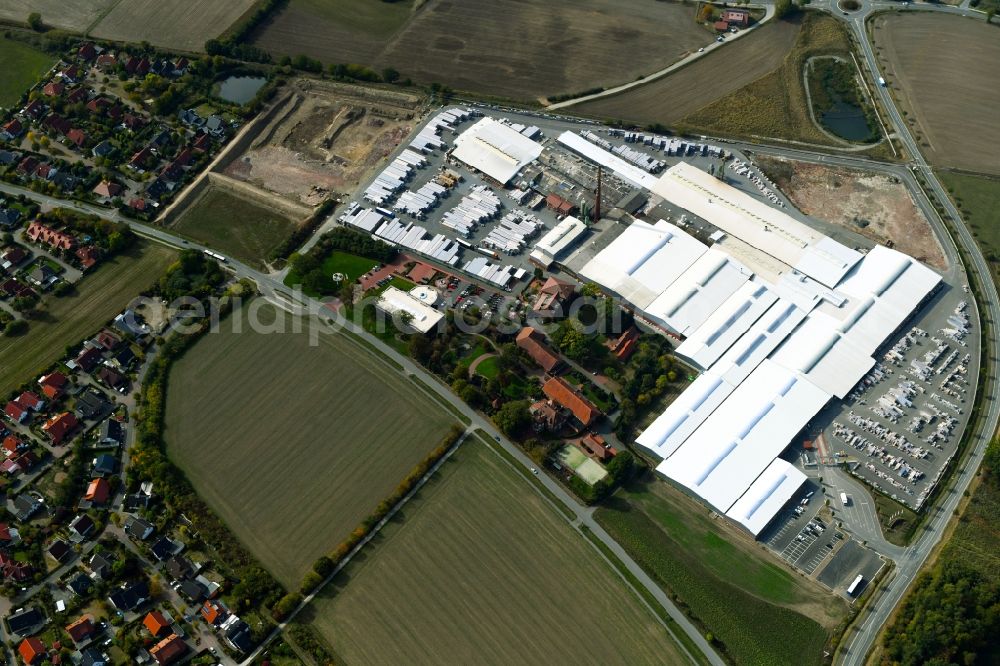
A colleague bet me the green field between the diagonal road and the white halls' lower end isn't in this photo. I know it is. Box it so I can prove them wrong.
[595,476,847,664]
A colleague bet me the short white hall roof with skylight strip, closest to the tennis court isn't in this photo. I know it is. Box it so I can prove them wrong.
[635,372,734,458]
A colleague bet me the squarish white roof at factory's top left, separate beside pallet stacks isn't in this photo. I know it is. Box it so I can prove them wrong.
[452,117,542,184]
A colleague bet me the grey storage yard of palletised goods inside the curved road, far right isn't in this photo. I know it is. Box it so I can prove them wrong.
[824,286,979,512]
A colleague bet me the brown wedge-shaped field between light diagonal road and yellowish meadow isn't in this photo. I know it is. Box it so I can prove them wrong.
[571,21,799,125]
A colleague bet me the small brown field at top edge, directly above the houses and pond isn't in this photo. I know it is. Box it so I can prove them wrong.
[91,0,254,51]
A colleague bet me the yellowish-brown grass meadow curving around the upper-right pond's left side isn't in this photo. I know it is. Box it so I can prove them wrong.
[677,11,880,145]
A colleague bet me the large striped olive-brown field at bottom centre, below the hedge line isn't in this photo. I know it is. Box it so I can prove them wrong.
[310,438,687,664]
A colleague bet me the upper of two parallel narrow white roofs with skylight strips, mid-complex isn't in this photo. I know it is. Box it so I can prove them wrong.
[677,281,778,370]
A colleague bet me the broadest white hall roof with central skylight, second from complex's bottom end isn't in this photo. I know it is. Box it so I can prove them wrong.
[657,360,830,512]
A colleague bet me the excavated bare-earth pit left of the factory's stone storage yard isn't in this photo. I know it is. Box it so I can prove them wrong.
[224,81,422,205]
